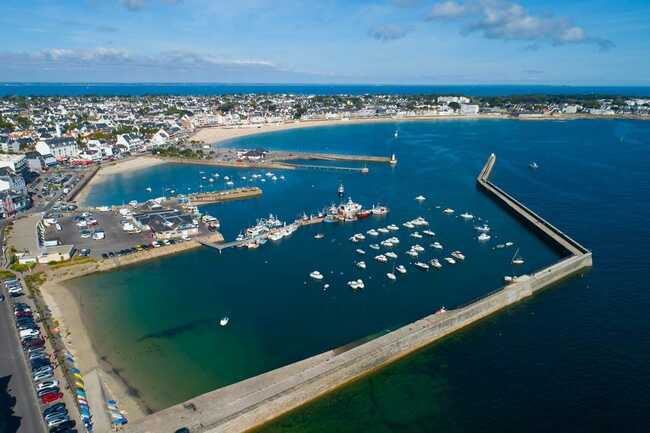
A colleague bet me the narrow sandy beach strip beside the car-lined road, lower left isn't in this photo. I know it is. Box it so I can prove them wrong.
[40,281,150,421]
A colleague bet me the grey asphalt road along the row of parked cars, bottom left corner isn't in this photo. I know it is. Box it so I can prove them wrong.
[0,288,47,433]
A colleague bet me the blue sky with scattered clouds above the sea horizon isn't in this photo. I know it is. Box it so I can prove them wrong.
[0,0,650,85]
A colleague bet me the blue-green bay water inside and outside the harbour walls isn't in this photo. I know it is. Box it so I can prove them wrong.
[68,116,650,432]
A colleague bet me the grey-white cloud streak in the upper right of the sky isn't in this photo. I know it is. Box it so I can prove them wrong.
[428,0,614,50]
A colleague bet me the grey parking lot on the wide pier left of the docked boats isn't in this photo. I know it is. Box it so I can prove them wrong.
[46,212,153,258]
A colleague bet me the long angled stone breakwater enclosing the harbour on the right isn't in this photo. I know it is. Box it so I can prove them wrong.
[125,155,592,433]
